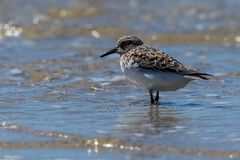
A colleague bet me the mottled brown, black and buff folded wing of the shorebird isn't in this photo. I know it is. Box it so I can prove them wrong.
[129,46,211,79]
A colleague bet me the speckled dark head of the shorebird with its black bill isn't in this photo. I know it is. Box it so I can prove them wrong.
[100,35,143,58]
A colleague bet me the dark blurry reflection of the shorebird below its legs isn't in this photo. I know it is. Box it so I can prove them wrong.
[116,102,183,135]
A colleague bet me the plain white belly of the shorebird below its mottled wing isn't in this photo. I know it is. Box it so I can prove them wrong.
[122,68,193,91]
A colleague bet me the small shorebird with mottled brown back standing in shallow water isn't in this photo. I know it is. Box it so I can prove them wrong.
[100,35,212,104]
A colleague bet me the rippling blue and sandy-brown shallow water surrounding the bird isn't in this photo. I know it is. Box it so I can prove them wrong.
[0,0,240,160]
